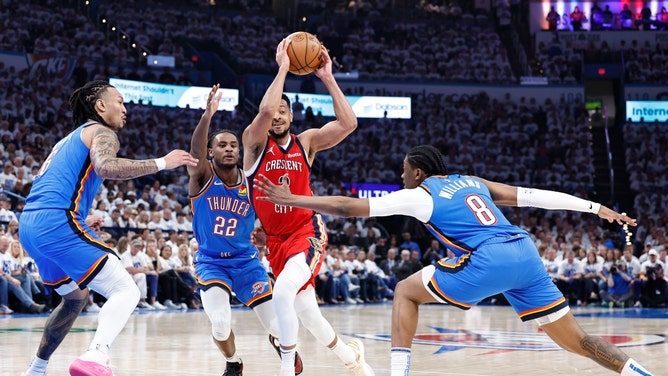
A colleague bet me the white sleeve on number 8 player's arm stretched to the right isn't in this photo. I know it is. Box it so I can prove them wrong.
[517,187,601,214]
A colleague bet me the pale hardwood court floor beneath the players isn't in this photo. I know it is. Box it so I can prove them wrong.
[0,303,668,376]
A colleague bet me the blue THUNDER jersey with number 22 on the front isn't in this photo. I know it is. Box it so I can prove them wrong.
[190,163,257,259]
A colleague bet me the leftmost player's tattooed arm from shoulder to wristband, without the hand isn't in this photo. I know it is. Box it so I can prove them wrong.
[90,127,158,180]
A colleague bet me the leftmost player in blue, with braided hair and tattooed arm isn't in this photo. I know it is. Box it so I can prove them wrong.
[19,81,197,376]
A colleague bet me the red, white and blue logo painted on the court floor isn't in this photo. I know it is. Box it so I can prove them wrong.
[357,326,666,354]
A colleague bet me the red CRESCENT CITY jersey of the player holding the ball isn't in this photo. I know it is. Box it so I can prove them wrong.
[248,134,317,235]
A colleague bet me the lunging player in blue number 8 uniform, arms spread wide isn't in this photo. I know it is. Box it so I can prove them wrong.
[254,146,651,376]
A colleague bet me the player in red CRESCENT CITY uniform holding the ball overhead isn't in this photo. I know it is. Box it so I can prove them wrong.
[242,39,374,376]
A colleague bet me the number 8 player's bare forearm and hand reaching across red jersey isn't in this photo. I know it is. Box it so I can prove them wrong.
[253,174,369,217]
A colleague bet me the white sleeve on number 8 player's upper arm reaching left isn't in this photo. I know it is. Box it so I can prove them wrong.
[369,188,434,223]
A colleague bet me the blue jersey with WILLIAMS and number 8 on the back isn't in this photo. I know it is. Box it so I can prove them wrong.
[420,175,528,256]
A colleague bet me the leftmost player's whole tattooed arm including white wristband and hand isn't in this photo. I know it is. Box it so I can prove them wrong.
[90,125,197,180]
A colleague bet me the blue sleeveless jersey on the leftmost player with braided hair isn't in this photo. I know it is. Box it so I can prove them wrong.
[23,122,103,218]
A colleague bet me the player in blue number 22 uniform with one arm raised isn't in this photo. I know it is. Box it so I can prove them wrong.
[188,85,303,376]
